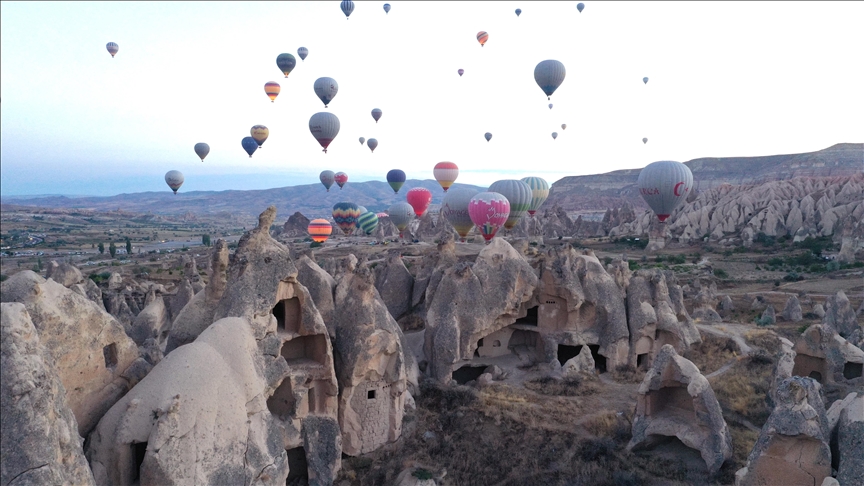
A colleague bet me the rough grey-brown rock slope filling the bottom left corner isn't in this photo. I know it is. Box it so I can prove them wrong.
[0,303,93,486]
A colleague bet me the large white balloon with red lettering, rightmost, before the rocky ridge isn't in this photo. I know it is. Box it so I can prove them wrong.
[636,160,693,221]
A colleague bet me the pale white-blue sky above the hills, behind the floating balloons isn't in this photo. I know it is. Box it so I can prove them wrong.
[0,0,864,195]
